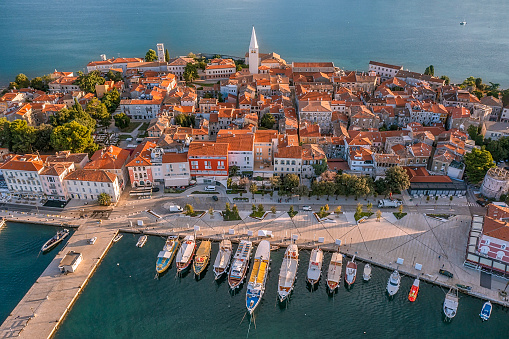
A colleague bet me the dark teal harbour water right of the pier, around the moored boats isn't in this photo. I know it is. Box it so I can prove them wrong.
[56,234,509,338]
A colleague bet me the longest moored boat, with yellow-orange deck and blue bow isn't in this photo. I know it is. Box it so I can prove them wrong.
[246,240,270,314]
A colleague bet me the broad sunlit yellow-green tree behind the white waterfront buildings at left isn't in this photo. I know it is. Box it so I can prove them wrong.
[50,121,98,153]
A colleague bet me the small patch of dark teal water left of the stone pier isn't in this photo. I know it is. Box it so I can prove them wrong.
[0,223,72,323]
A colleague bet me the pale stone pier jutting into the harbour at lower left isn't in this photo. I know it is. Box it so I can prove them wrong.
[0,218,117,338]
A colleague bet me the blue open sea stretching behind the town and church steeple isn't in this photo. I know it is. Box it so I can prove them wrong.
[0,0,509,88]
